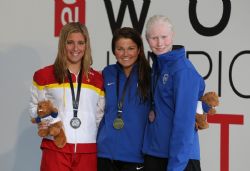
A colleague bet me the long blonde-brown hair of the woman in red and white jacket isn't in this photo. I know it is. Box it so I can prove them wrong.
[54,22,93,84]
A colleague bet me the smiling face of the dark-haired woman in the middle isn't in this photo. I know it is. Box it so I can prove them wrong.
[114,38,140,76]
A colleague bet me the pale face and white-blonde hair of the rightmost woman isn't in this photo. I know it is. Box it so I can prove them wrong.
[147,22,174,55]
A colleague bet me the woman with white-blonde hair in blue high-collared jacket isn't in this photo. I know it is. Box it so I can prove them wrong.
[143,15,205,171]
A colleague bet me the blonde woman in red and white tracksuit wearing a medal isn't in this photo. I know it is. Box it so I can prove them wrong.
[30,22,104,171]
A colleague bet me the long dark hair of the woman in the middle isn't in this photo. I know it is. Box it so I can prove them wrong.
[112,27,150,102]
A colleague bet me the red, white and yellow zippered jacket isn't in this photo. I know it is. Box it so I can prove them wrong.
[30,65,104,153]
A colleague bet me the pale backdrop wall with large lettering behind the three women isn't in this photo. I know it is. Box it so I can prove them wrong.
[0,0,250,171]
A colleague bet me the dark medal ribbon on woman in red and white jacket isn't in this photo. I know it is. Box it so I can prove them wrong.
[67,68,82,117]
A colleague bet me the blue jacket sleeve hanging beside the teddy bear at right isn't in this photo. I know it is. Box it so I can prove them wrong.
[167,69,203,171]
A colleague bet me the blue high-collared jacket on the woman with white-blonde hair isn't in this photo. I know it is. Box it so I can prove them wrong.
[143,46,205,171]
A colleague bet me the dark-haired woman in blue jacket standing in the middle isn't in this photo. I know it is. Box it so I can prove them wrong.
[97,27,150,171]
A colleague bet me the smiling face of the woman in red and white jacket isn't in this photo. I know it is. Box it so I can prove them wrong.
[66,33,86,67]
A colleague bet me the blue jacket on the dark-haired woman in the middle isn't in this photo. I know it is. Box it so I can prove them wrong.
[97,64,150,163]
